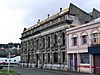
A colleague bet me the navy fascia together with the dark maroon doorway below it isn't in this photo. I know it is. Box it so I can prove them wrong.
[88,46,100,74]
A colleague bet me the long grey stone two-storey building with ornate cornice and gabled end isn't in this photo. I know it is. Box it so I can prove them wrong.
[20,4,100,70]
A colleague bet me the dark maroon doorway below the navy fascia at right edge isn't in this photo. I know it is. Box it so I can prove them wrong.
[93,55,100,74]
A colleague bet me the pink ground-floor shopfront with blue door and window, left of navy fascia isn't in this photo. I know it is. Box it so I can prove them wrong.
[67,53,93,73]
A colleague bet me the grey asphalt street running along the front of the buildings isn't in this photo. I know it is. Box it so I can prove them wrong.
[3,66,95,75]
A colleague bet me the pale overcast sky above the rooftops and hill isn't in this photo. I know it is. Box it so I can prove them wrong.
[0,0,100,44]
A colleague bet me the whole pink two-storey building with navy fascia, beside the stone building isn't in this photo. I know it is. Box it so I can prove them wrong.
[66,18,100,73]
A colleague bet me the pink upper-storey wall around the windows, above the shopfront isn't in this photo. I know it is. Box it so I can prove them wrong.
[66,23,100,53]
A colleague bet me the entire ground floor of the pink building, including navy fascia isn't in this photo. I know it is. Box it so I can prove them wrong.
[67,47,100,74]
